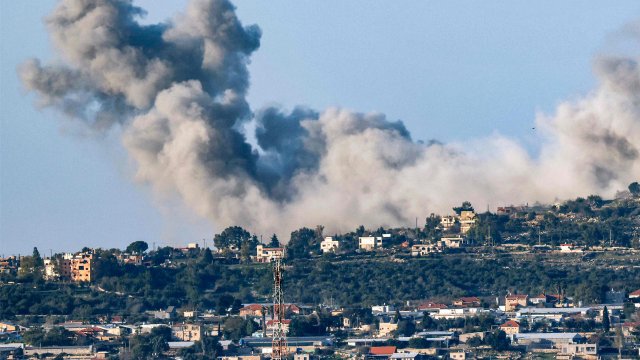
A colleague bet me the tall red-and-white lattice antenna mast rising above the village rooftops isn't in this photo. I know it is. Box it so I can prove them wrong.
[271,256,287,360]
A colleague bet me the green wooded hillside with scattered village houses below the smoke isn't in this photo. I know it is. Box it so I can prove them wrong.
[0,187,640,360]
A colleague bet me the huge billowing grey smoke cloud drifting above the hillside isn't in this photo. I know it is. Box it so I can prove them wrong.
[20,0,640,239]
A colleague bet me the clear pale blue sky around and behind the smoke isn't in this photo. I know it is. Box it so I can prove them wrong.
[0,0,640,256]
